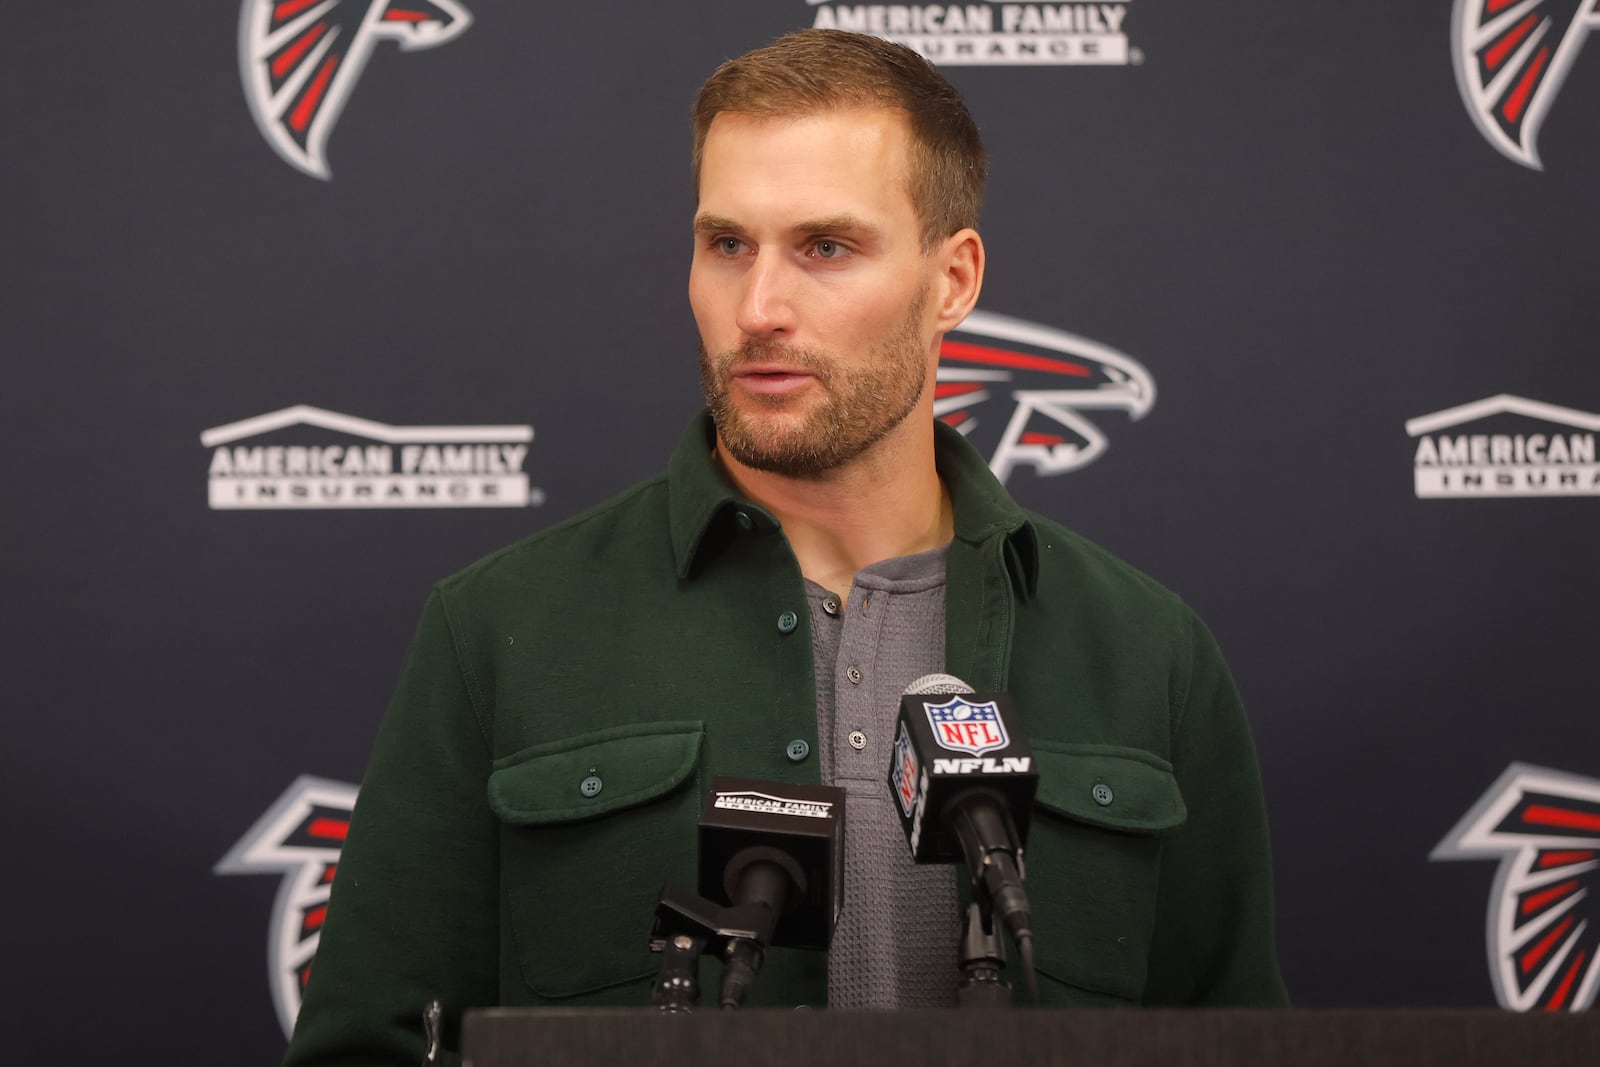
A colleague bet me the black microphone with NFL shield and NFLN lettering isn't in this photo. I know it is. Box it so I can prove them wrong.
[888,675,1038,977]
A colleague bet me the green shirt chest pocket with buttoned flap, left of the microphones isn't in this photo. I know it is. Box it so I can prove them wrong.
[488,721,704,1003]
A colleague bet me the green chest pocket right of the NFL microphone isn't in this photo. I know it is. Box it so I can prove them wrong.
[1027,741,1187,1005]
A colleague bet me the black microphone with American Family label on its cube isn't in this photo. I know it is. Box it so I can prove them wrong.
[699,777,845,1008]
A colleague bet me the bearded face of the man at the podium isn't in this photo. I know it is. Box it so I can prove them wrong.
[690,109,936,475]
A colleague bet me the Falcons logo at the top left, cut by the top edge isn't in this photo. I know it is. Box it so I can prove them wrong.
[238,0,472,181]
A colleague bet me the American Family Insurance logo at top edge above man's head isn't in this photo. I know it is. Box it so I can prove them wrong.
[806,0,1144,67]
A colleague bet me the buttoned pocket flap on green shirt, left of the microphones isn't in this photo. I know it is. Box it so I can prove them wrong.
[488,721,706,825]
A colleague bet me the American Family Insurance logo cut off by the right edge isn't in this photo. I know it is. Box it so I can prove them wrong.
[1405,394,1600,499]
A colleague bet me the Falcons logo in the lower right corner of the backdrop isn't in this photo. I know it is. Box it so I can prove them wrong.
[1429,763,1600,1011]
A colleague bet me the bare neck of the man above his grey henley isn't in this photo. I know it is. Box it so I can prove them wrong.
[717,416,955,598]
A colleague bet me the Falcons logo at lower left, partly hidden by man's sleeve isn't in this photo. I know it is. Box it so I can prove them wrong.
[214,774,355,1037]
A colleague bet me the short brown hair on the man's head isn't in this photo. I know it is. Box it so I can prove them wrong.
[694,29,989,250]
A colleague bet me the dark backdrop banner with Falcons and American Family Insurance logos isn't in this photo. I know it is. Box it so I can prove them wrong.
[0,0,1600,1065]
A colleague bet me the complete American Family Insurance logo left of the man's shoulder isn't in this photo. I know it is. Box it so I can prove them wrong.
[200,405,544,510]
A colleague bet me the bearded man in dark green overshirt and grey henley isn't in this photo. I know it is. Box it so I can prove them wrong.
[288,30,1285,1064]
